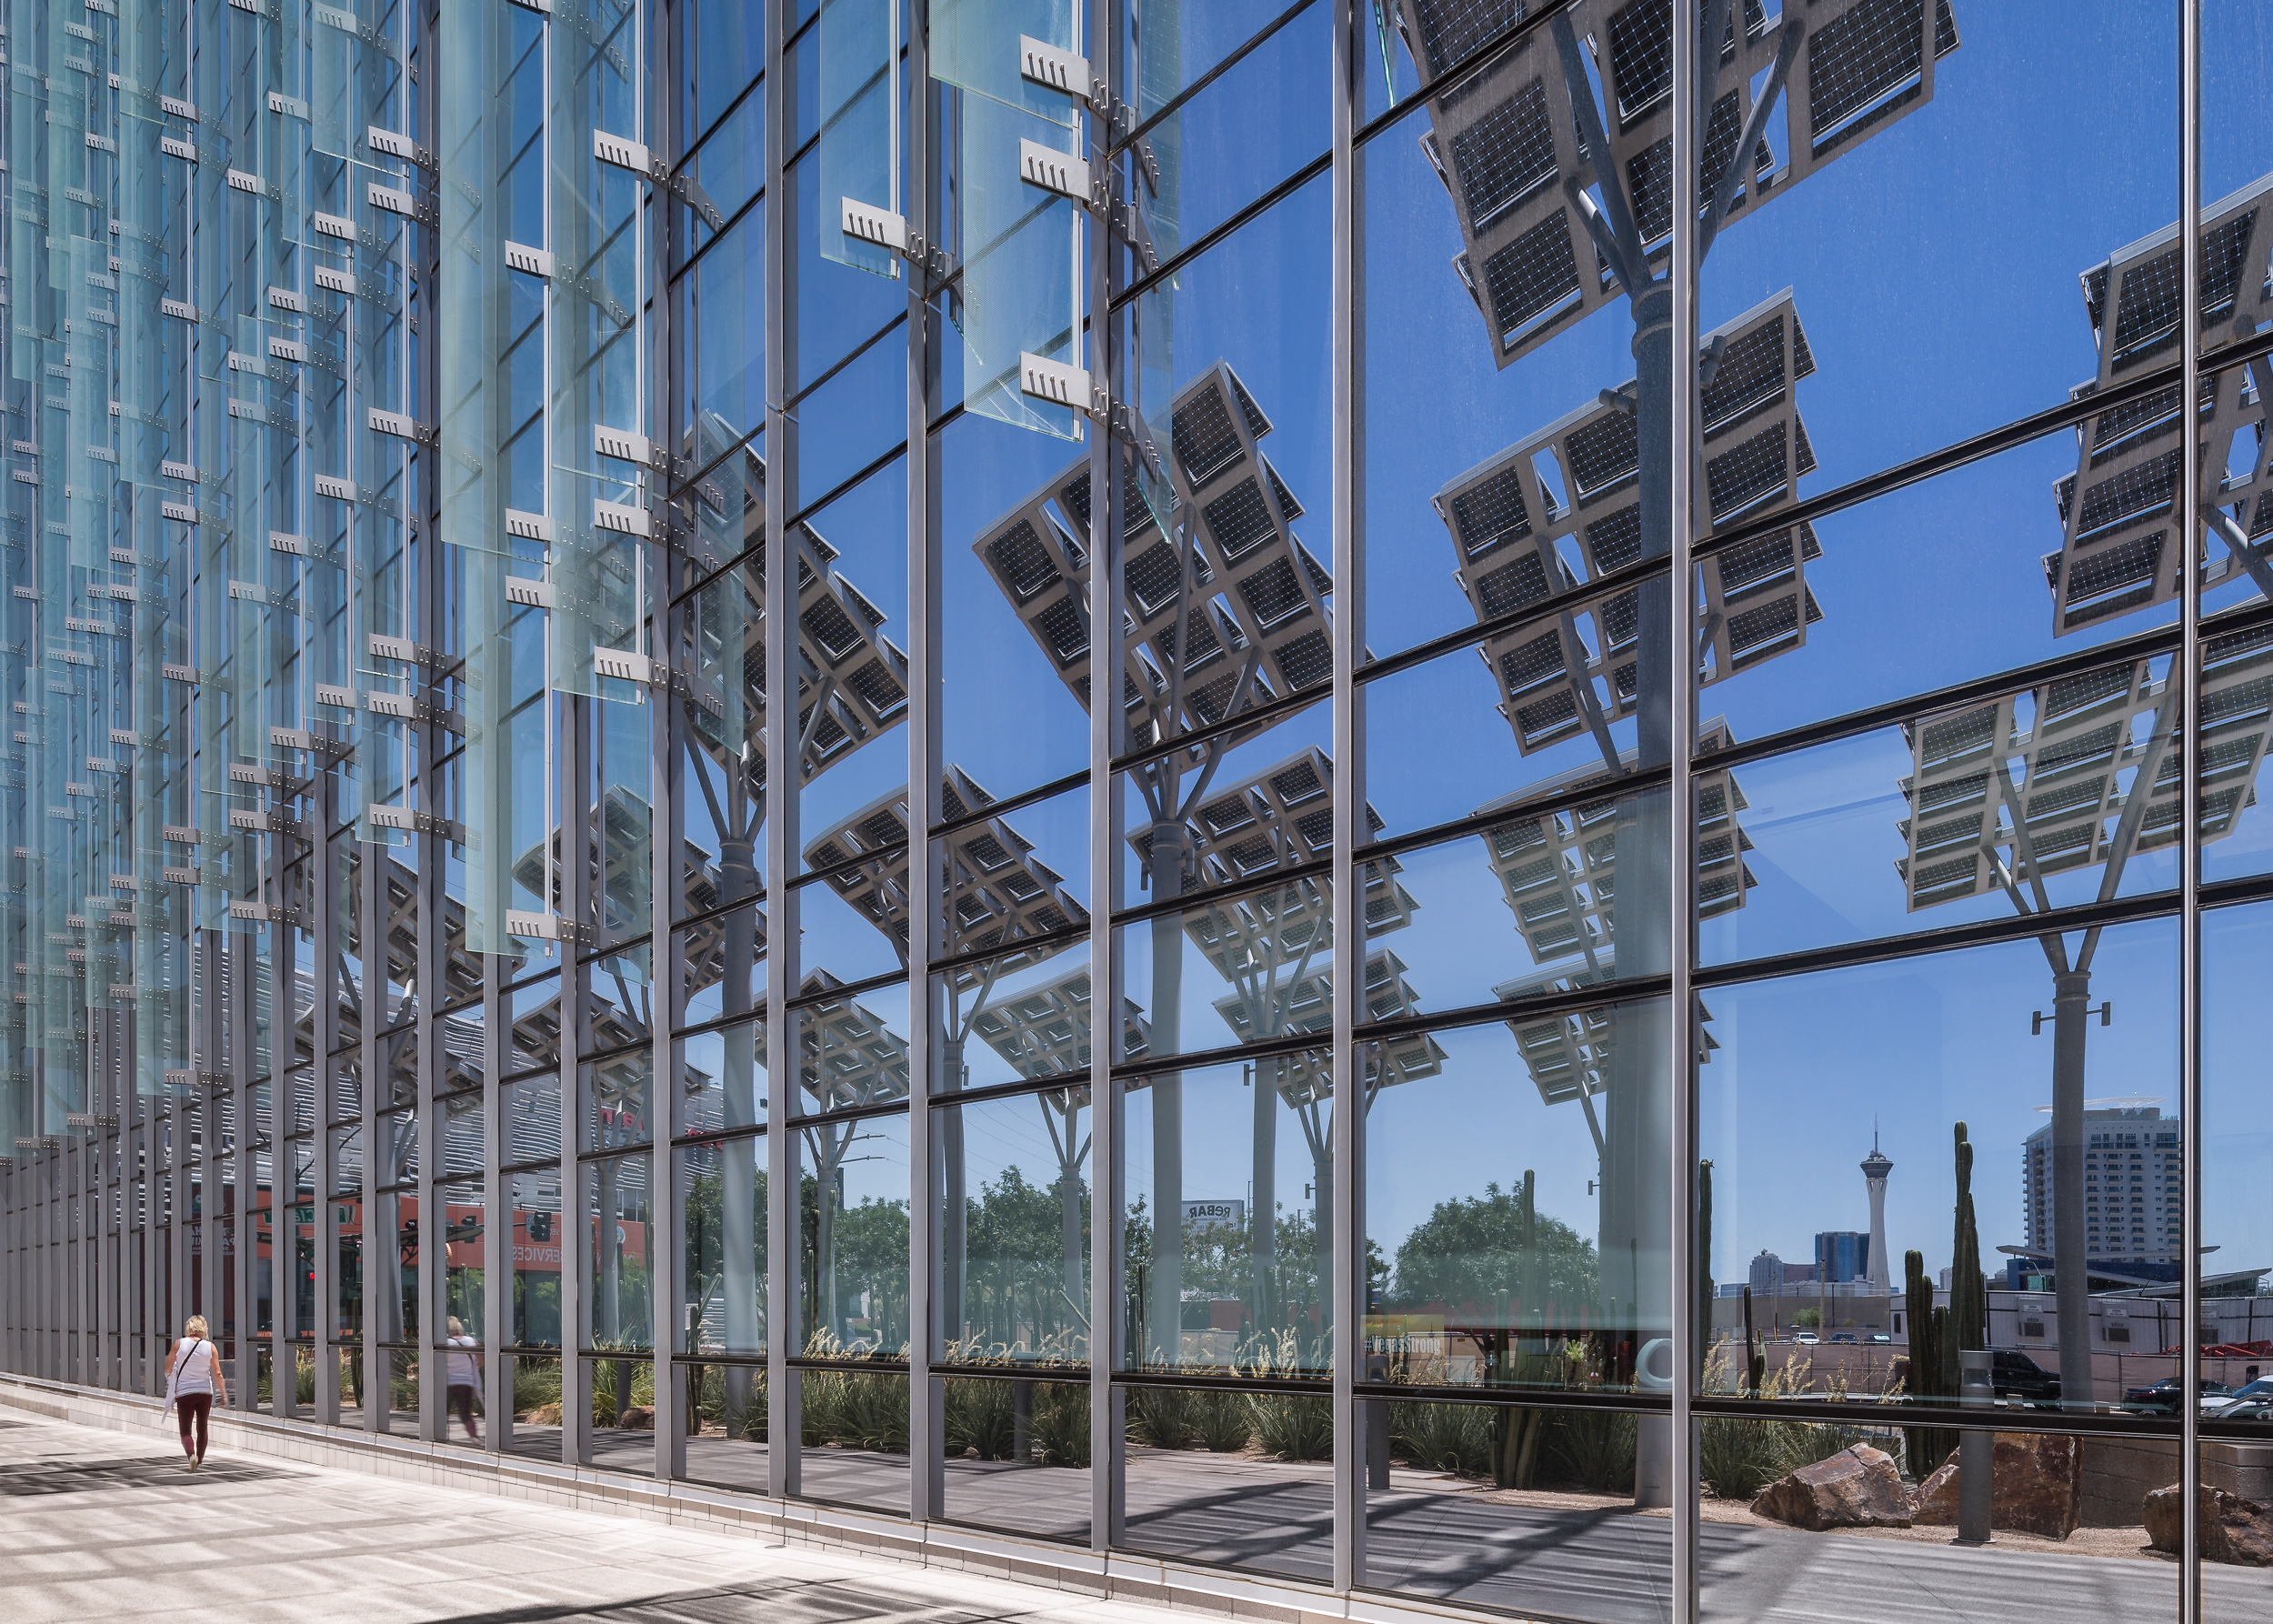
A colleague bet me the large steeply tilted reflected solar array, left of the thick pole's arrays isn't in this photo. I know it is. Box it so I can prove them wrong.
[976,362,1335,748]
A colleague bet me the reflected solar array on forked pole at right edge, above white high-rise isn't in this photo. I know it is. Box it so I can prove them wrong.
[1896,630,2273,910]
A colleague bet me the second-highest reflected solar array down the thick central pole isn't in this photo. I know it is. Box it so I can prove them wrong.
[1435,289,1823,755]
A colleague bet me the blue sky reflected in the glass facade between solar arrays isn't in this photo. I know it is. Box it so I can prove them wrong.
[768,0,2273,1278]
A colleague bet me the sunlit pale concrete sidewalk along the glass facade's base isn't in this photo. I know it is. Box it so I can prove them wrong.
[0,1412,1191,1624]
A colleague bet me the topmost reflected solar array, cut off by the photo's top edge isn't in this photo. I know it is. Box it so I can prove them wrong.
[1396,0,1958,366]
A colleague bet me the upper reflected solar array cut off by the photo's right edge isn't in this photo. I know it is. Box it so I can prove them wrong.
[2044,175,2273,637]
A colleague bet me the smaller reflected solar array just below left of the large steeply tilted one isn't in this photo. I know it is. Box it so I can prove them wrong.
[805,764,1089,989]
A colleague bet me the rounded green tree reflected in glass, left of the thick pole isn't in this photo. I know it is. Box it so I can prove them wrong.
[1389,1183,1600,1321]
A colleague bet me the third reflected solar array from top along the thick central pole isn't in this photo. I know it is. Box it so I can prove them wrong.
[1477,717,1757,978]
